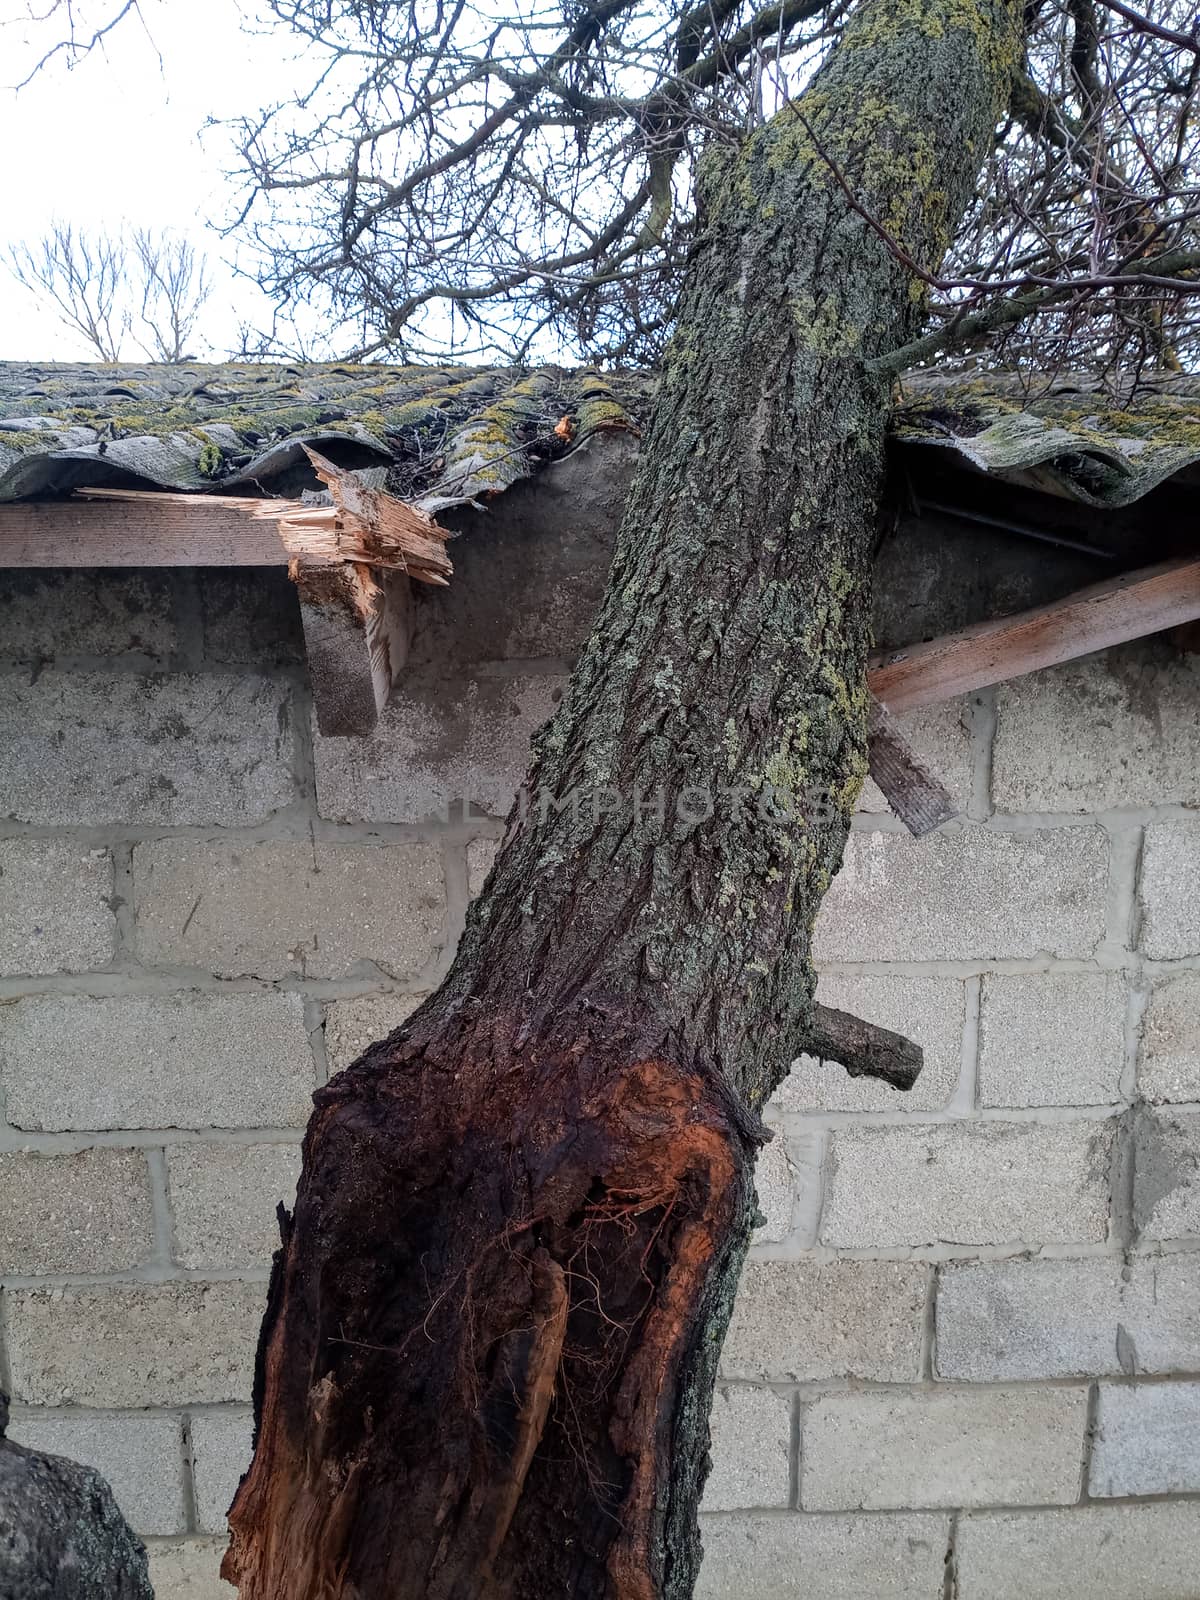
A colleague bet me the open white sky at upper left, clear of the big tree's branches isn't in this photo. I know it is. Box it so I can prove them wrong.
[0,0,298,360]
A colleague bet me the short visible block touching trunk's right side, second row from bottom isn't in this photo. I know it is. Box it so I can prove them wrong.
[704,1387,792,1510]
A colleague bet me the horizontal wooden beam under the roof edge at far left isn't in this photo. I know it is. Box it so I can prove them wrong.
[0,490,291,566]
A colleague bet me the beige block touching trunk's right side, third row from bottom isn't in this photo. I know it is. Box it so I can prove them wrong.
[722,1261,928,1382]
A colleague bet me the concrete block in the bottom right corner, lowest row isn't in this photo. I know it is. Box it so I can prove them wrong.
[955,1501,1200,1600]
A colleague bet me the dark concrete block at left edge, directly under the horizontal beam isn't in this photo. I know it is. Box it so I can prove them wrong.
[0,566,179,661]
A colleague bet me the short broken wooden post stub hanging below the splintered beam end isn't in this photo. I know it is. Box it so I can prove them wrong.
[299,562,411,738]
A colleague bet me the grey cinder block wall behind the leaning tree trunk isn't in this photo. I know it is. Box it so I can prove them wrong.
[0,478,1200,1600]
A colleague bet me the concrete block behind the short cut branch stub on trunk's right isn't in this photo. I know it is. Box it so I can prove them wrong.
[771,973,966,1114]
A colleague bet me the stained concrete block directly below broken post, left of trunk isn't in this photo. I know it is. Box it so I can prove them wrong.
[314,669,566,822]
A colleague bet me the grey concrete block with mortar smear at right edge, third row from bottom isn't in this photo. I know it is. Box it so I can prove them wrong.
[936,1253,1200,1382]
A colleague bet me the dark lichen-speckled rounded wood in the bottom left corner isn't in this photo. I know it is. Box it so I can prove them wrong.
[0,1394,154,1600]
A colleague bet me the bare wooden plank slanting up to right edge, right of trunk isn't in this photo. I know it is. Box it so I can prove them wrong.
[867,558,1200,712]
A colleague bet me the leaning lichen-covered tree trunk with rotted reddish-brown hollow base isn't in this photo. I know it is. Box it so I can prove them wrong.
[226,0,1021,1600]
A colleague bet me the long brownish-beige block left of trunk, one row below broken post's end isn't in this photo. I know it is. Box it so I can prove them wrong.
[133,844,446,978]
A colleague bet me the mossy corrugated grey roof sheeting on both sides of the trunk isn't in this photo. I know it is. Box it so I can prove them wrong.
[0,362,1200,512]
